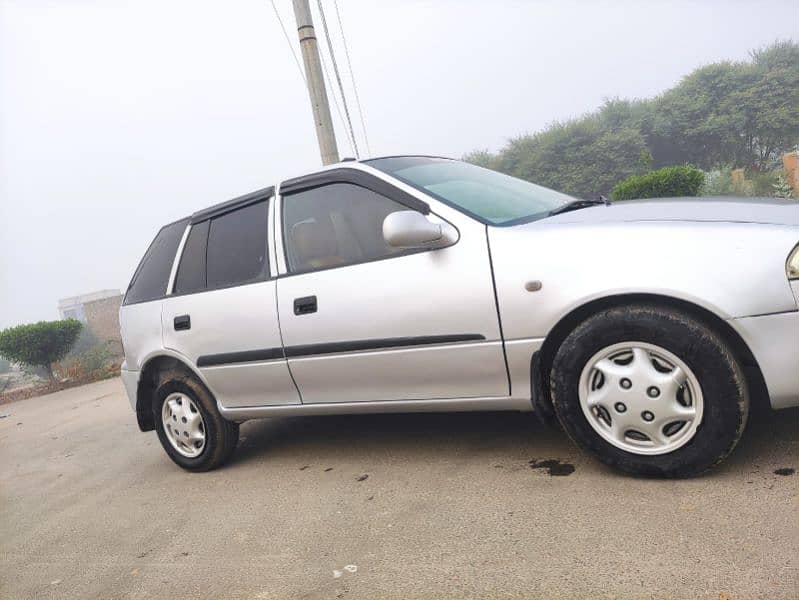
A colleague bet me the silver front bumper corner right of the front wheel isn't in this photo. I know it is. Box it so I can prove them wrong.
[730,312,799,408]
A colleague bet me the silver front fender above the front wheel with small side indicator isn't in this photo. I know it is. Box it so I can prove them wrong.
[489,219,799,340]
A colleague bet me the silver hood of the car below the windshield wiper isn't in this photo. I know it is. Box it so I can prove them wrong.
[536,198,799,226]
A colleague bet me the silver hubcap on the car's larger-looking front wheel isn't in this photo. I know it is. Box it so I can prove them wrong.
[579,342,703,455]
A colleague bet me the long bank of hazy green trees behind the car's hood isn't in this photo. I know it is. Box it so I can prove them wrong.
[464,40,799,191]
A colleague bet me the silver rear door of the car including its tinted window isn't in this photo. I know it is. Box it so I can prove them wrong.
[161,188,300,407]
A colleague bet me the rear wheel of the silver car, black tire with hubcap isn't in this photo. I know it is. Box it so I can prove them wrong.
[153,370,239,471]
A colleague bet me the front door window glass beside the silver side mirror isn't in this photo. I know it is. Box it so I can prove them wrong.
[283,183,408,272]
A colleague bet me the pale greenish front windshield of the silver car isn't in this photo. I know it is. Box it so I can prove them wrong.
[364,156,575,225]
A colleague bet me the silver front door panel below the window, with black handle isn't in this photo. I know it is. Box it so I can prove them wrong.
[275,180,509,403]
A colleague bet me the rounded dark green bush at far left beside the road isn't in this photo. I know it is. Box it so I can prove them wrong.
[0,319,83,380]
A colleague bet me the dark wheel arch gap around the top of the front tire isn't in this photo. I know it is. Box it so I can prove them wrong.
[531,293,771,423]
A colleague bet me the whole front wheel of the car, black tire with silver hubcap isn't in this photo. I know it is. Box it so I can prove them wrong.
[550,305,749,477]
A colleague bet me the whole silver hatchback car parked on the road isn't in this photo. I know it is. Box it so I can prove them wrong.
[120,156,799,477]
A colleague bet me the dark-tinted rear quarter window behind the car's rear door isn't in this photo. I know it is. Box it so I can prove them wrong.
[125,219,188,304]
